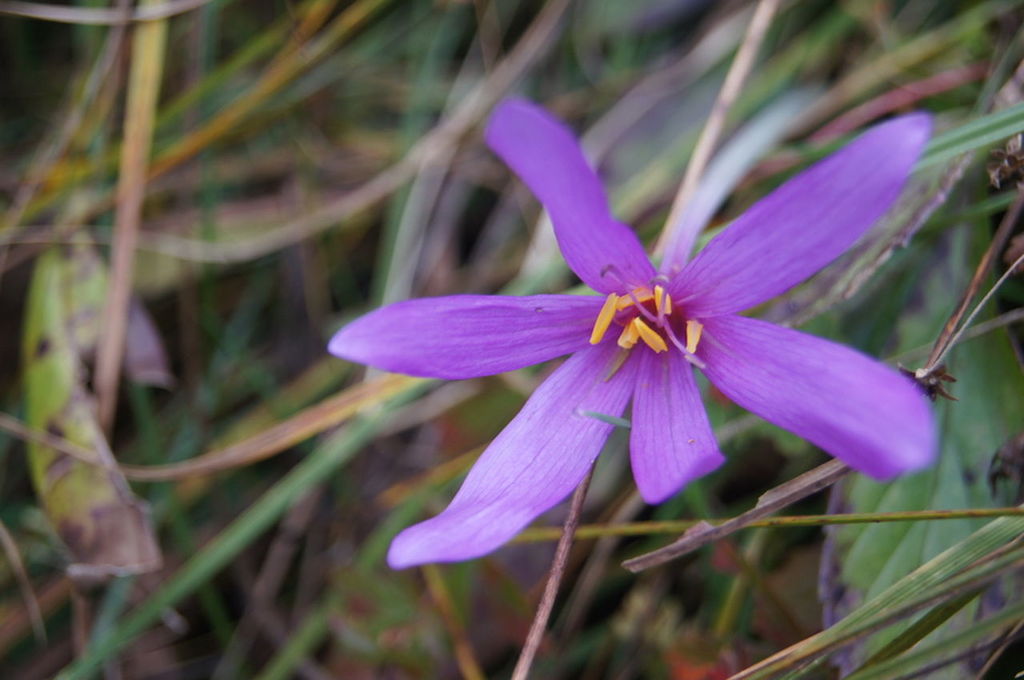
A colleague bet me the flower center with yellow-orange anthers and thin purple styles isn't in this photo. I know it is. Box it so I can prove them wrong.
[590,286,703,360]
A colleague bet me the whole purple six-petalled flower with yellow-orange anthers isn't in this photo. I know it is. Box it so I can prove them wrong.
[330,100,935,568]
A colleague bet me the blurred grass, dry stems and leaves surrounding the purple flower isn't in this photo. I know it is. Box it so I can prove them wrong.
[0,0,1024,680]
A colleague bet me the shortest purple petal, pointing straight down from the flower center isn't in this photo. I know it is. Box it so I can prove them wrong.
[630,351,725,503]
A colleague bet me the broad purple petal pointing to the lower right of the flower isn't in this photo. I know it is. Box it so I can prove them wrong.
[697,316,936,479]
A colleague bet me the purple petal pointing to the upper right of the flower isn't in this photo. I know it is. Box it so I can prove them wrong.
[670,114,931,317]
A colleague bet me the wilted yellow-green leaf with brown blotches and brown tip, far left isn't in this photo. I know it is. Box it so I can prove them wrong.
[23,250,161,579]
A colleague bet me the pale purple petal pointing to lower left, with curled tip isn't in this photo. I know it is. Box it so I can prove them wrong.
[388,342,636,568]
